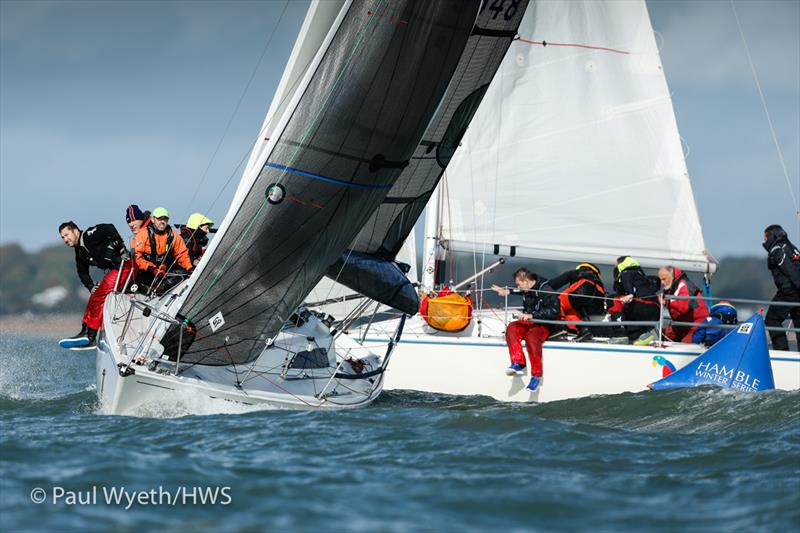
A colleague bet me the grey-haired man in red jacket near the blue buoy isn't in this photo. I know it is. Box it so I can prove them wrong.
[658,265,708,343]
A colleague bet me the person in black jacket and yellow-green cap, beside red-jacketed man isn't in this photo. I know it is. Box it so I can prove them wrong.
[609,256,661,344]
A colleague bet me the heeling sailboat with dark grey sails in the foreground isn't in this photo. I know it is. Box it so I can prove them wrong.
[97,0,527,414]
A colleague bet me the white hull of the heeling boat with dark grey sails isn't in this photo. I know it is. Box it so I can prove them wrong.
[97,294,396,416]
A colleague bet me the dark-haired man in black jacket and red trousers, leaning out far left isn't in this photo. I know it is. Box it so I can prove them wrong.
[58,220,133,348]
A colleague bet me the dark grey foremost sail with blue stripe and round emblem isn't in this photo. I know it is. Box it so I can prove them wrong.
[171,0,478,365]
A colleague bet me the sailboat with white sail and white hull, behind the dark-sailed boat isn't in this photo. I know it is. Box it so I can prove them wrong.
[351,0,800,402]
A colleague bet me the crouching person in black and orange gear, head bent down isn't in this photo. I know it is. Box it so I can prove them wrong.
[548,263,606,340]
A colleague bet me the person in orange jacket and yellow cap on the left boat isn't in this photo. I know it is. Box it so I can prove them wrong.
[133,207,192,284]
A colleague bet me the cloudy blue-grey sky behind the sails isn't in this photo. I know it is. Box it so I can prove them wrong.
[0,0,800,258]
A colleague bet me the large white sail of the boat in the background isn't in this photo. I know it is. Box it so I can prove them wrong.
[441,0,715,271]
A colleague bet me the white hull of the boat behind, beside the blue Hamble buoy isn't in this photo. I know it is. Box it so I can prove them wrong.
[352,315,800,402]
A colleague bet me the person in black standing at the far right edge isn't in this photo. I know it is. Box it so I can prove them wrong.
[763,224,800,350]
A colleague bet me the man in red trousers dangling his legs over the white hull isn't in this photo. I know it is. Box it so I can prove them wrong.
[492,268,561,391]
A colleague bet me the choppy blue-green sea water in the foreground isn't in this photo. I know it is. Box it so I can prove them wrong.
[0,333,800,532]
